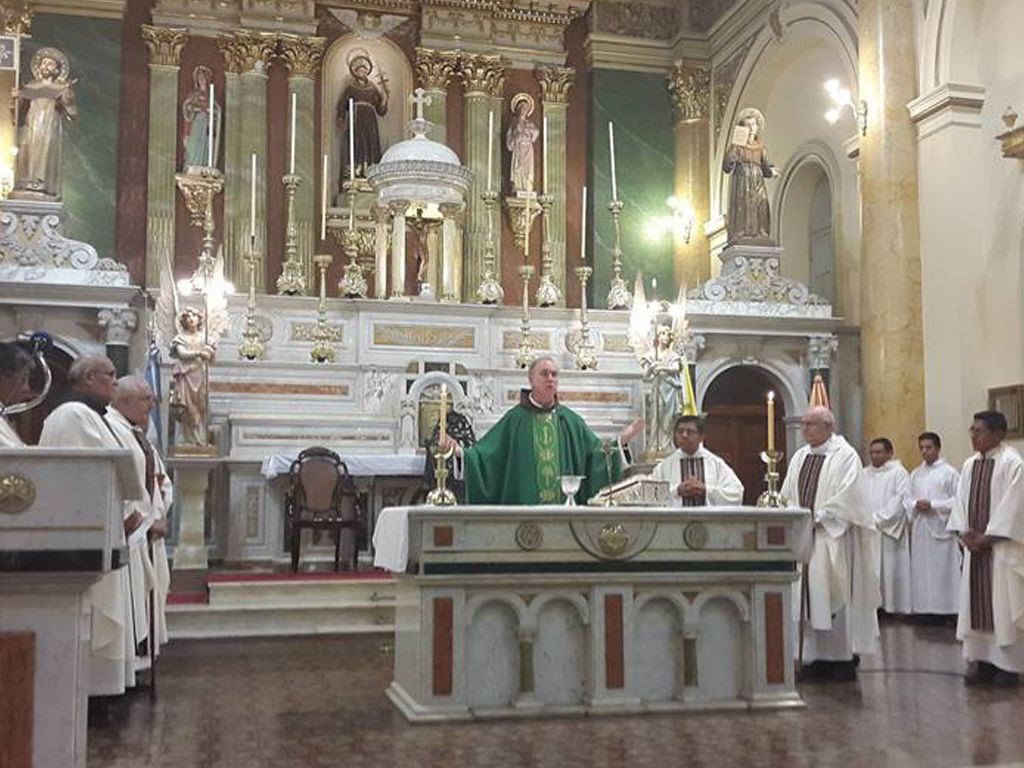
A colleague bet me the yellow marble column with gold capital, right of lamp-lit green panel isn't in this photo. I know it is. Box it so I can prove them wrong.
[669,61,711,287]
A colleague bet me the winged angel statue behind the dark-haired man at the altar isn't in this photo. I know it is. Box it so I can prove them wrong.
[629,274,696,460]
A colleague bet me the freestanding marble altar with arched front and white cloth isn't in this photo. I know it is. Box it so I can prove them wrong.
[375,506,810,722]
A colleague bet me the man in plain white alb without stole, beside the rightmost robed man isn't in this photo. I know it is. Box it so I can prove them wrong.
[904,432,961,615]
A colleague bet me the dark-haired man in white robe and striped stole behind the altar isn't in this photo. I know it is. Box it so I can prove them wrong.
[651,415,743,507]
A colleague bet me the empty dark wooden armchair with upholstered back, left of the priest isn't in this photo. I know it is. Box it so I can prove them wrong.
[285,447,365,572]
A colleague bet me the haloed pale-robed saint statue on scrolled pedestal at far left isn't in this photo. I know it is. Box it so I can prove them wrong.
[11,48,78,200]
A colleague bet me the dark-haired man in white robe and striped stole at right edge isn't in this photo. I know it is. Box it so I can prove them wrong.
[948,411,1024,686]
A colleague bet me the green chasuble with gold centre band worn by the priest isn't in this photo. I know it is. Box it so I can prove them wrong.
[463,391,622,505]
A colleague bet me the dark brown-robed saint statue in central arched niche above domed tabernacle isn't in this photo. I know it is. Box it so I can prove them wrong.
[337,48,389,183]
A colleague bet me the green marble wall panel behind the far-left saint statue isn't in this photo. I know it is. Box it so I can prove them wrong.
[22,13,122,257]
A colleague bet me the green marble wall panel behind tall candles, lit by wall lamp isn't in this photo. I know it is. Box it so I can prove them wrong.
[587,70,676,307]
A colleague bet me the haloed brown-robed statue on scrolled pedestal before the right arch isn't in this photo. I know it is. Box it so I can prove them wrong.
[722,106,778,246]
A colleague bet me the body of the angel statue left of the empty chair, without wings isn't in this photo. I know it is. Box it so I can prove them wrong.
[170,307,217,447]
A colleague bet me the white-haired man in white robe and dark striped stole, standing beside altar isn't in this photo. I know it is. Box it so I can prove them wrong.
[782,406,880,681]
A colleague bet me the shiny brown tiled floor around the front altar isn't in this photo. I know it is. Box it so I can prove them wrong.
[88,624,1024,768]
